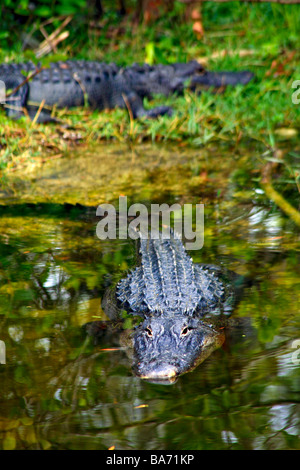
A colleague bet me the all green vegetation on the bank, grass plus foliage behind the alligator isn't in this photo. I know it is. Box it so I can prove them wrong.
[0,0,300,225]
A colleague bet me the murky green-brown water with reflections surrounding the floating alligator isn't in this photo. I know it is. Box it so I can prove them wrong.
[0,142,300,450]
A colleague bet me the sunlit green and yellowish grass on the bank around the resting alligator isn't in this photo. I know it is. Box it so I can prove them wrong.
[0,2,300,171]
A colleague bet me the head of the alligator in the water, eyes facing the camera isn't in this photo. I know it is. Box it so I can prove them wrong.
[133,314,224,383]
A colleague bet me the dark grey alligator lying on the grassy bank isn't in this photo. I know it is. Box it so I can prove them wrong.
[0,60,253,122]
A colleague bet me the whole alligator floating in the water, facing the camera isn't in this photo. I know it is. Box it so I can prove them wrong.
[87,232,240,383]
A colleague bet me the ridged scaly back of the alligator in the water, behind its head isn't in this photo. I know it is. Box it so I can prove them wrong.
[117,233,224,316]
